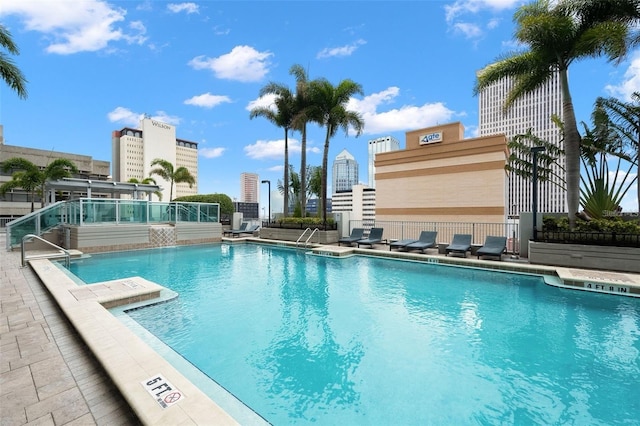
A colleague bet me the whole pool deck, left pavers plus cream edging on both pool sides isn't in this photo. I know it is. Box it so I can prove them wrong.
[0,233,640,426]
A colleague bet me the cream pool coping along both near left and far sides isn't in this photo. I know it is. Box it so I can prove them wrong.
[23,238,640,425]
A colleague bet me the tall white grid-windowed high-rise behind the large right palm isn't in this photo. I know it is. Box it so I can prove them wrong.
[478,73,567,216]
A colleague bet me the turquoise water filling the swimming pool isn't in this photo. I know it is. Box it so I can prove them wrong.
[71,244,640,425]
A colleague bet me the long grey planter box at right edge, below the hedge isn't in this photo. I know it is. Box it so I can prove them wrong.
[529,241,640,273]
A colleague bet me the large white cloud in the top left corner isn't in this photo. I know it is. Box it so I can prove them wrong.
[0,0,146,55]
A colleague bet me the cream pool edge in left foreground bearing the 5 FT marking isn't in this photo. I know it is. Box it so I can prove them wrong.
[29,259,238,425]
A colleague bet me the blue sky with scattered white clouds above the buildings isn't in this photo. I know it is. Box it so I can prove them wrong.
[0,0,640,210]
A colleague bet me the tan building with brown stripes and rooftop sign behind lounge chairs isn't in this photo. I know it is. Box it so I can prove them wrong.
[375,123,508,223]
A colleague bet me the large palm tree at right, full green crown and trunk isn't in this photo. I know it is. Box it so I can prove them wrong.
[474,0,640,228]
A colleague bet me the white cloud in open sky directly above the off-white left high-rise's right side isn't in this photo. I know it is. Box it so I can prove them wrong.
[189,46,273,82]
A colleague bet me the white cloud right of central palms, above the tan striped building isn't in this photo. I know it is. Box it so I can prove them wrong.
[347,87,456,135]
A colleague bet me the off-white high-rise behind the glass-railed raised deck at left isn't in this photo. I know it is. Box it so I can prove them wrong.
[111,117,198,201]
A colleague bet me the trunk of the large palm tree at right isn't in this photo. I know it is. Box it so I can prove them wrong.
[560,69,581,229]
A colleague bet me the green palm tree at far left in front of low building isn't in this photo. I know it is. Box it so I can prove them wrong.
[0,157,78,212]
